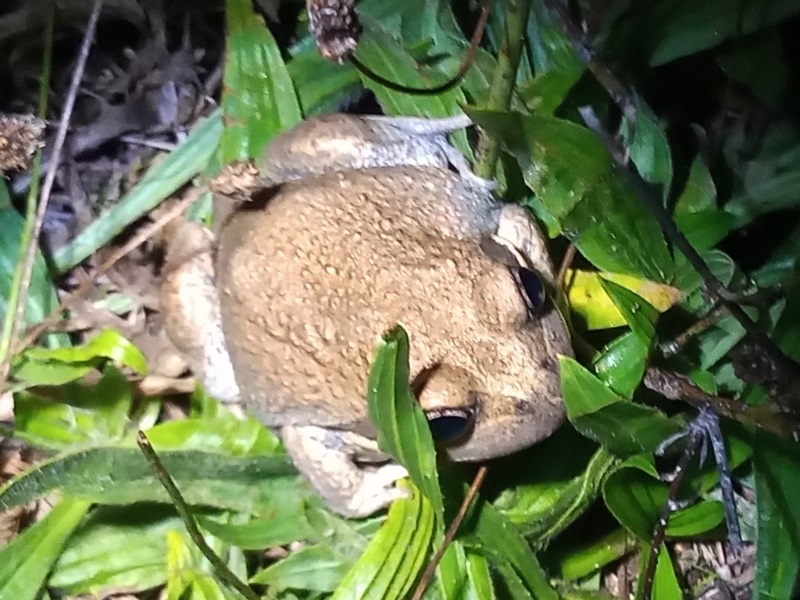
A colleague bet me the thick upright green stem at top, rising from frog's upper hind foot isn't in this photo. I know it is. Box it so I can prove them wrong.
[475,0,531,179]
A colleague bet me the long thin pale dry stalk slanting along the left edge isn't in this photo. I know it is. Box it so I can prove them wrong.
[0,0,103,380]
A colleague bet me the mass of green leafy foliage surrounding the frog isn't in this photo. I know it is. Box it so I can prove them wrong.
[0,0,800,599]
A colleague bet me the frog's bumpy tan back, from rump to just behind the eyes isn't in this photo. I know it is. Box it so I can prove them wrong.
[217,167,499,426]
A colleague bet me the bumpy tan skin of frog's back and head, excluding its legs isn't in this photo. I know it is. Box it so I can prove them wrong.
[216,167,570,461]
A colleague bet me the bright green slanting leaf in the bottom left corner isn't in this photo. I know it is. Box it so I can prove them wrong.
[0,498,90,600]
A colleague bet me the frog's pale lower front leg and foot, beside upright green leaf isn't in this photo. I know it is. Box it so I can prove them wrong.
[281,426,408,518]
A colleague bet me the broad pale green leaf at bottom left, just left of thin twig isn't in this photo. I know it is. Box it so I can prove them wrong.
[49,504,184,595]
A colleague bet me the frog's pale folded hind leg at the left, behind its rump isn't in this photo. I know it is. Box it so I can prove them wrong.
[161,222,239,404]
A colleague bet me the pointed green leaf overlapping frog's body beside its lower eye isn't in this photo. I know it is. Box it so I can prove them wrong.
[367,326,444,522]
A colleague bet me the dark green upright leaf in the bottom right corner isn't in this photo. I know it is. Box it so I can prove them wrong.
[753,434,800,600]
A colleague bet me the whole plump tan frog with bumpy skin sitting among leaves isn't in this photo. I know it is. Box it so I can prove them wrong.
[161,113,573,518]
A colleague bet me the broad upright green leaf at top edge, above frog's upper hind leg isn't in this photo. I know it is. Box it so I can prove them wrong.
[220,0,302,164]
